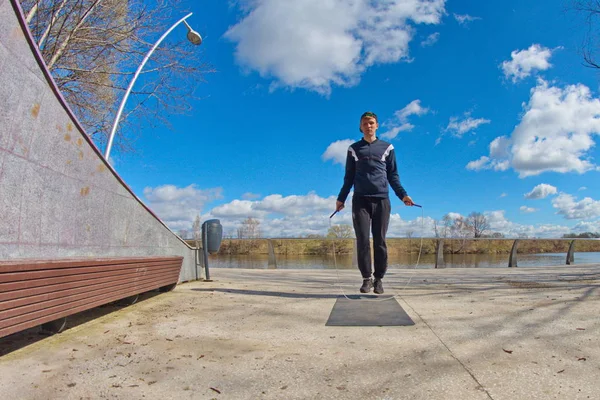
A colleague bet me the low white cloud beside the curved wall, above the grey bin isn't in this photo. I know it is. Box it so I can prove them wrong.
[144,185,223,232]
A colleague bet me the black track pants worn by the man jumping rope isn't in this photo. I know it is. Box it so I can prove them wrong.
[352,196,391,279]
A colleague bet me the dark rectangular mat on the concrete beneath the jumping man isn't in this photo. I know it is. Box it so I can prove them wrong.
[325,294,415,326]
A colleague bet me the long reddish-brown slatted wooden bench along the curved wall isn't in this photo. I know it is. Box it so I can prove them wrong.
[0,257,183,337]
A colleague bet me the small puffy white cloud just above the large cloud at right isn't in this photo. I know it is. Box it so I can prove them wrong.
[501,44,552,82]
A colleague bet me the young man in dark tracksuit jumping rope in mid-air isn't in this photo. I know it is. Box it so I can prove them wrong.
[335,112,415,294]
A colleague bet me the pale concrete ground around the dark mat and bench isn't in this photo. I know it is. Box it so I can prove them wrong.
[0,264,600,400]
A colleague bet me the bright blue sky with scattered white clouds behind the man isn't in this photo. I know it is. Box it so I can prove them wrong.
[112,0,600,237]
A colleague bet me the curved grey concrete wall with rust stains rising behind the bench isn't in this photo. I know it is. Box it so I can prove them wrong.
[0,0,196,281]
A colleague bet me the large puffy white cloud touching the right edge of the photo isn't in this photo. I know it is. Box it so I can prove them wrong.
[469,80,600,178]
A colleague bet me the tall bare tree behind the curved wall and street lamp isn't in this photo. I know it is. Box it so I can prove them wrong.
[21,0,210,150]
